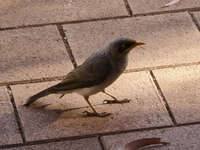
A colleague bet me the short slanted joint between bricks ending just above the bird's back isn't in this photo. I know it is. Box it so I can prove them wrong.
[57,25,77,68]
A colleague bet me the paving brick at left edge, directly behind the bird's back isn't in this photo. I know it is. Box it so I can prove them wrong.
[0,26,73,82]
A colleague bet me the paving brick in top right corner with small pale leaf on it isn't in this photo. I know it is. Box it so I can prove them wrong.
[128,0,200,15]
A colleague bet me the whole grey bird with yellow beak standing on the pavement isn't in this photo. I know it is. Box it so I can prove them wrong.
[24,38,145,117]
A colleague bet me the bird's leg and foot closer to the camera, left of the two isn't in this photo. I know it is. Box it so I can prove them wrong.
[84,96,110,117]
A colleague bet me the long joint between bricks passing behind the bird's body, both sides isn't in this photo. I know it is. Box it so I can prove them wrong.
[0,62,200,86]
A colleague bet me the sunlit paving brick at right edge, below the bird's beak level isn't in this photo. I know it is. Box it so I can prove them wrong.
[153,66,200,123]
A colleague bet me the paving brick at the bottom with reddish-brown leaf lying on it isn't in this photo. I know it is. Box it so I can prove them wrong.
[103,125,200,150]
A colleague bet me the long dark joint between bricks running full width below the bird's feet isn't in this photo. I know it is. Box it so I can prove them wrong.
[0,121,200,149]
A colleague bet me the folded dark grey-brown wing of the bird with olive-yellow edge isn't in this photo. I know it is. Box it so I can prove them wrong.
[50,57,112,92]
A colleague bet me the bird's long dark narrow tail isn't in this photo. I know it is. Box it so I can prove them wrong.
[24,87,52,106]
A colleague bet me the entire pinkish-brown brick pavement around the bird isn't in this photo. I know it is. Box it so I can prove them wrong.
[0,0,200,150]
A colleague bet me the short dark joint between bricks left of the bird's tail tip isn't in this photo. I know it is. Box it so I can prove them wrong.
[7,86,26,143]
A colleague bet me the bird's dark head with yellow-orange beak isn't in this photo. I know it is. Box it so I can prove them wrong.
[109,38,145,58]
